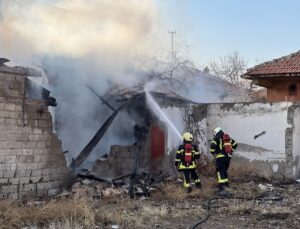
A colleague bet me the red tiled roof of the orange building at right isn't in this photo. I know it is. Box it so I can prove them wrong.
[242,51,300,79]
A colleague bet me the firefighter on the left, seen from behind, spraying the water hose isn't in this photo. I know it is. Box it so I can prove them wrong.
[175,132,201,193]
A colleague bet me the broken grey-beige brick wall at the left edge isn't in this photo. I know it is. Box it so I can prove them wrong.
[0,72,71,199]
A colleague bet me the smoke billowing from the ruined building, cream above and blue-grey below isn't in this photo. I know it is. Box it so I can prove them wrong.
[0,0,239,166]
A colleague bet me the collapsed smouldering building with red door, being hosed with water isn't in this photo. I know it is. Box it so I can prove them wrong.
[72,84,194,177]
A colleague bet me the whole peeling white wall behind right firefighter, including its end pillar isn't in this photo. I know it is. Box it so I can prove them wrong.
[189,102,300,179]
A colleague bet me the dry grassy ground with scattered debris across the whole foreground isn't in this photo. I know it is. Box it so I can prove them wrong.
[0,178,300,229]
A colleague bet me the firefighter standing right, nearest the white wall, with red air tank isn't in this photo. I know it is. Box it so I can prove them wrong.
[210,127,238,191]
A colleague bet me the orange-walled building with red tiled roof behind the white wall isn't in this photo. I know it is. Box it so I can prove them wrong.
[242,51,300,102]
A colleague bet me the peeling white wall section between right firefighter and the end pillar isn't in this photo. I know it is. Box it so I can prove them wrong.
[207,103,291,180]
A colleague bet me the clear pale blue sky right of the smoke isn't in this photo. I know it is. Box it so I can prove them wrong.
[156,0,300,66]
